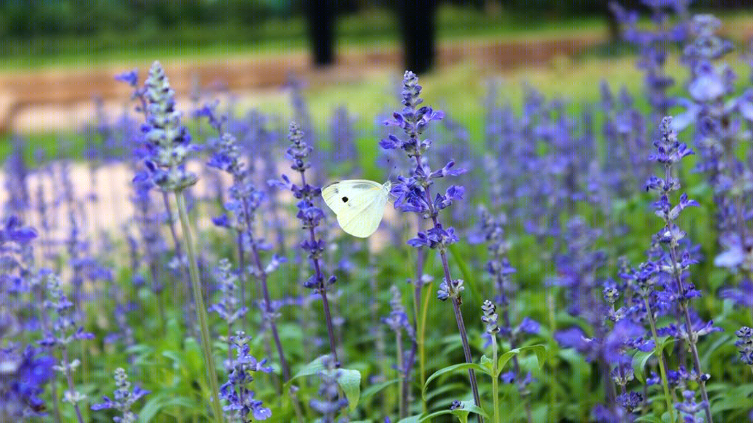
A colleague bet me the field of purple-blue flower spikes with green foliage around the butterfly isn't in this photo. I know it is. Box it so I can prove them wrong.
[0,1,753,423]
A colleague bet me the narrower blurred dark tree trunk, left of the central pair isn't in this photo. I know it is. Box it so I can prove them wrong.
[305,0,335,67]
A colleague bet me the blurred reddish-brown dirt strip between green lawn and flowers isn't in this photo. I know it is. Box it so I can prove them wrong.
[0,34,603,134]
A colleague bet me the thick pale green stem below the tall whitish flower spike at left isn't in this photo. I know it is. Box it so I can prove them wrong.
[175,191,223,422]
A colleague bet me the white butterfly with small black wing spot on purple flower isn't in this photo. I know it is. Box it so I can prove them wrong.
[322,179,392,238]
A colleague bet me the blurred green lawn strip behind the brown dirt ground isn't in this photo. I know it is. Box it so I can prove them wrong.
[0,5,753,71]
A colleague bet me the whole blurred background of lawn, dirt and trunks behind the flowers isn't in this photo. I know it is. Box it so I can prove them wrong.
[0,0,753,148]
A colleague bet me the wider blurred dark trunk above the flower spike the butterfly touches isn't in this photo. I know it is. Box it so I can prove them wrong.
[397,0,438,74]
